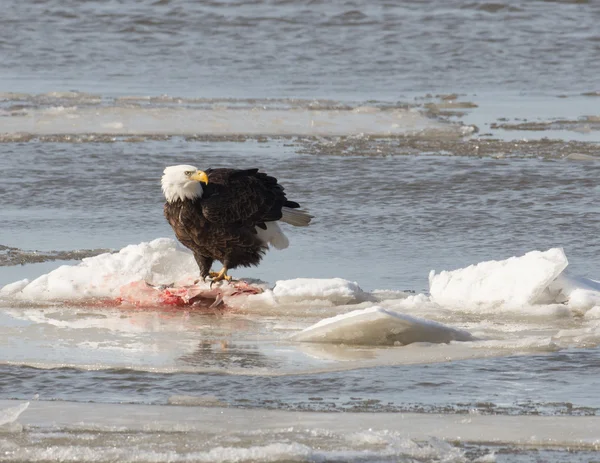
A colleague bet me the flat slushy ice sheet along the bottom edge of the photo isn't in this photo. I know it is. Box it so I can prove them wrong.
[7,401,600,454]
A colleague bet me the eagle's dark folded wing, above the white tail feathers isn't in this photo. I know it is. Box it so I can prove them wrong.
[201,169,290,225]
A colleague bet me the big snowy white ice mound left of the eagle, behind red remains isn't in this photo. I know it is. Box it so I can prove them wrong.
[1,238,198,300]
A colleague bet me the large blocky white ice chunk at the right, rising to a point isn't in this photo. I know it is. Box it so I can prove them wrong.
[429,248,568,308]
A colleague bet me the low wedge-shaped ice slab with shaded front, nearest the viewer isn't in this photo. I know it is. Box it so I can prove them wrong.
[293,306,474,346]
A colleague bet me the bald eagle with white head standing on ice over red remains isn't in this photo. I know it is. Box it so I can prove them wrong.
[161,165,312,282]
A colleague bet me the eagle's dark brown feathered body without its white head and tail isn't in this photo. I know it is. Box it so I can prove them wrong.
[164,169,300,278]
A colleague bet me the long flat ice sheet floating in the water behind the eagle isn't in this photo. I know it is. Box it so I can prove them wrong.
[2,105,473,138]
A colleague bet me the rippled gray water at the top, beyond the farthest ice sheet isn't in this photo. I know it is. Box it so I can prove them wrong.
[0,0,600,101]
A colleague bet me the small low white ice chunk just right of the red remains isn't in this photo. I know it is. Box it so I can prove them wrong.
[273,278,369,304]
